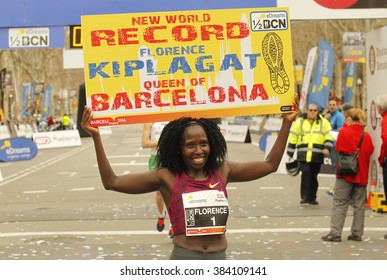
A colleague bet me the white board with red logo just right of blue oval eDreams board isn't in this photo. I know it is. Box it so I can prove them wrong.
[32,129,82,149]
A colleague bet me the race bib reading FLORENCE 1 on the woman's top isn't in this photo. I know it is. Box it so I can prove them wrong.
[182,190,229,236]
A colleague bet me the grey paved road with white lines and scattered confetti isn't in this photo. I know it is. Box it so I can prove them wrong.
[0,125,387,260]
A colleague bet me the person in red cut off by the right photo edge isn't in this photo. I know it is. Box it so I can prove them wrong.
[376,95,387,239]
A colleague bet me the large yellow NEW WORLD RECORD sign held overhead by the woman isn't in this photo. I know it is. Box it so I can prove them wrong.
[81,8,294,126]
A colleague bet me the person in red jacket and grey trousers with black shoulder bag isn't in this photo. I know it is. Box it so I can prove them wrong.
[321,108,374,242]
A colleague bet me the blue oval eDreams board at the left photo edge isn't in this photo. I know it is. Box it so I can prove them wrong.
[0,137,38,161]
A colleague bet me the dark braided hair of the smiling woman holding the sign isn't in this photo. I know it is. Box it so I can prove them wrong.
[156,117,227,174]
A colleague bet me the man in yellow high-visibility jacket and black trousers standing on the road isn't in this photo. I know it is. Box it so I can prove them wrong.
[287,103,334,205]
